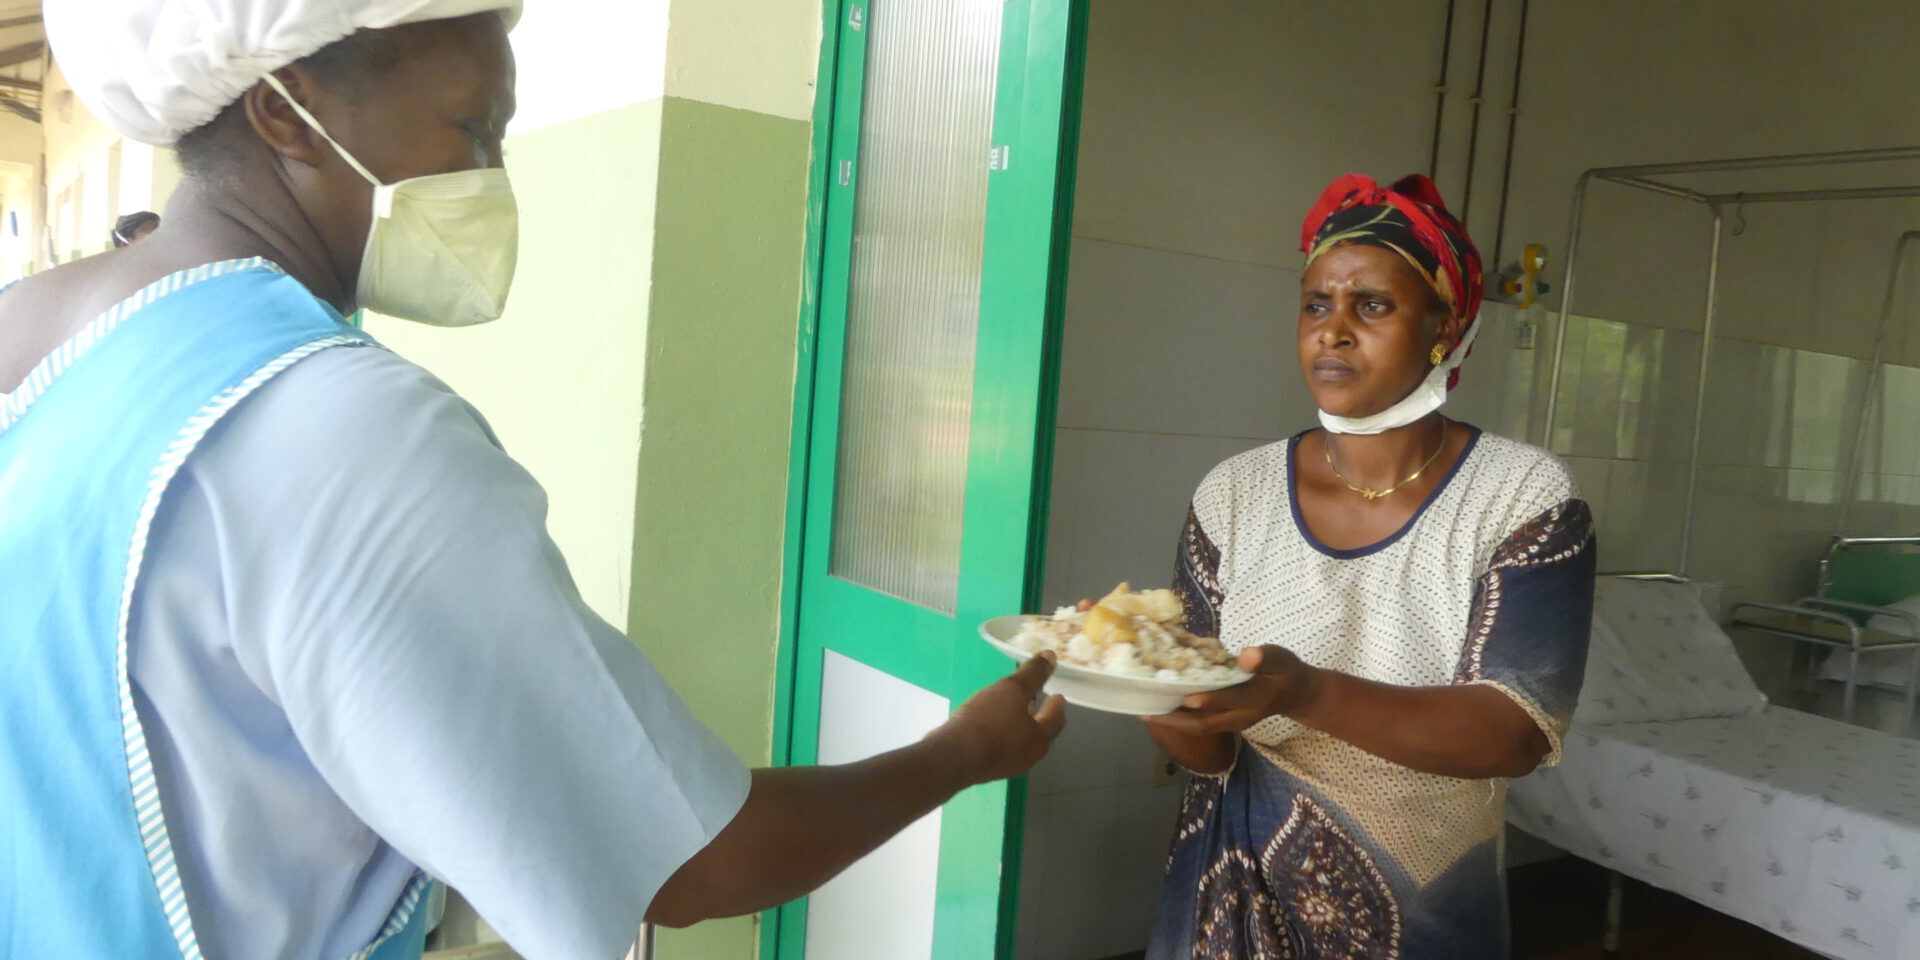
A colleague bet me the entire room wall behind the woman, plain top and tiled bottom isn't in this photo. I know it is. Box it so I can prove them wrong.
[1018,0,1920,960]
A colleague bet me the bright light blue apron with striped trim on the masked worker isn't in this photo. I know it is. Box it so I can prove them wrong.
[0,259,428,960]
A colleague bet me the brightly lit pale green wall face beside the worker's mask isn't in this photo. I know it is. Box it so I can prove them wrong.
[367,100,660,624]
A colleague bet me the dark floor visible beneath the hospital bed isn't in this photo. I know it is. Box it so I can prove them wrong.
[1108,856,1820,960]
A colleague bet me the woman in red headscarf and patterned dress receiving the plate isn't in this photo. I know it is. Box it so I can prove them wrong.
[1148,175,1594,960]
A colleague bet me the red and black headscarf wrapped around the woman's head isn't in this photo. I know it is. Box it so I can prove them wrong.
[1300,173,1484,388]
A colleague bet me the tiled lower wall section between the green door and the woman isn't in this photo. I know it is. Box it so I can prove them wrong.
[1018,238,1282,960]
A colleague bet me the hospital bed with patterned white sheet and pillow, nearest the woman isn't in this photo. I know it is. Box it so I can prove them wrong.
[1507,576,1920,960]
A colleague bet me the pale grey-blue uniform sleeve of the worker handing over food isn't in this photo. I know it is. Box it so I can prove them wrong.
[205,348,749,958]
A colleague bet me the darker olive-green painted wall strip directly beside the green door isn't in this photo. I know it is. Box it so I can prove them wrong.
[628,98,810,960]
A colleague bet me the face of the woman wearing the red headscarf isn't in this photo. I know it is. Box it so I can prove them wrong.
[1300,244,1452,417]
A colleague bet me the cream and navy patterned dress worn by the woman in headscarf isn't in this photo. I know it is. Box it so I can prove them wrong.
[1146,430,1596,960]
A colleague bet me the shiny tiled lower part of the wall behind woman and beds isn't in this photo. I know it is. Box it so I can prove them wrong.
[1020,238,1920,960]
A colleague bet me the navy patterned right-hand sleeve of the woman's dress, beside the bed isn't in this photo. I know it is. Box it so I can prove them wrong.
[1453,499,1596,766]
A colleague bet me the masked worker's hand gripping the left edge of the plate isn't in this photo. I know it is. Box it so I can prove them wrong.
[927,653,1068,783]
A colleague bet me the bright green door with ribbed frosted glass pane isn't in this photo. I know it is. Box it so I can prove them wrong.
[766,0,1085,960]
